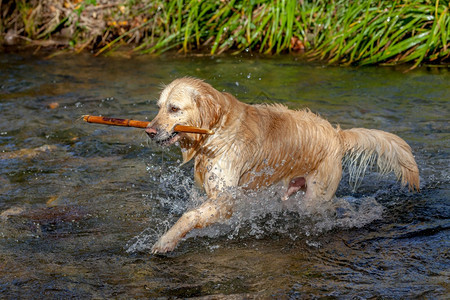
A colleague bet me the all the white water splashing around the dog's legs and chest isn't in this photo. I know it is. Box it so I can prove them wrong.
[126,159,383,253]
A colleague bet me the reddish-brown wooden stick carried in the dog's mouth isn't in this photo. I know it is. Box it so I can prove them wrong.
[83,115,214,134]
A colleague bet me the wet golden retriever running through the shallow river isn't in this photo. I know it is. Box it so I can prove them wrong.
[146,78,419,253]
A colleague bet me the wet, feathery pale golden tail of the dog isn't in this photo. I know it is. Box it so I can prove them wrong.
[339,128,419,191]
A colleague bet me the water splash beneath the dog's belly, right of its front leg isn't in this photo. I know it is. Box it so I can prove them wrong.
[187,185,383,240]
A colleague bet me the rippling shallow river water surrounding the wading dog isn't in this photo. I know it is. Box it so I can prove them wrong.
[0,53,450,299]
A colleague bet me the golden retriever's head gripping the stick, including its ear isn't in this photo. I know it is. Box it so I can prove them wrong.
[146,78,222,146]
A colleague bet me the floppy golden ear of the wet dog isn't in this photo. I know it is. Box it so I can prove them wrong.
[194,91,223,128]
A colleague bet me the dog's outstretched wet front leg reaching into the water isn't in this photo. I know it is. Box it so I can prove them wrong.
[152,198,231,254]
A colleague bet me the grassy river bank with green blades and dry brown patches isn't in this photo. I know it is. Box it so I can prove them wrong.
[0,0,450,66]
